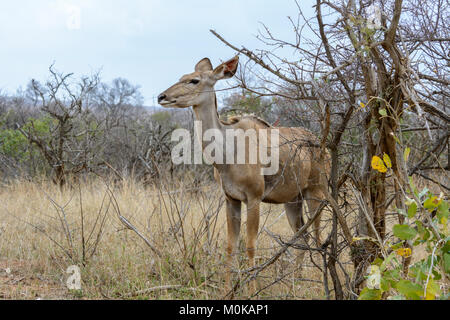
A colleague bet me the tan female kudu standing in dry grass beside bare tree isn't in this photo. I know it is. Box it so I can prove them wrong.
[158,56,329,296]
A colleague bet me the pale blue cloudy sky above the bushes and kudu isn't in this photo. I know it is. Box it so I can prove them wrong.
[0,0,315,106]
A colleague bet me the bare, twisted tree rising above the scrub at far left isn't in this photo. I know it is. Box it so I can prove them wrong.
[18,65,99,188]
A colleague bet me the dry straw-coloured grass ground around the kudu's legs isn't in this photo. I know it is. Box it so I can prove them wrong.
[0,176,442,299]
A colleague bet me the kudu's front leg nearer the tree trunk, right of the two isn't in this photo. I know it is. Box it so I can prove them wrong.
[247,199,261,294]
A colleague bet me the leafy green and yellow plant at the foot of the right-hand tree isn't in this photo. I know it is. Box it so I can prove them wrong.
[359,158,450,300]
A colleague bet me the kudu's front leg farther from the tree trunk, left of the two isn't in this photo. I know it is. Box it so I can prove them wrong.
[225,198,241,298]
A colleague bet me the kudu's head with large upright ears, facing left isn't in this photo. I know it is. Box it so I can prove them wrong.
[158,56,239,108]
